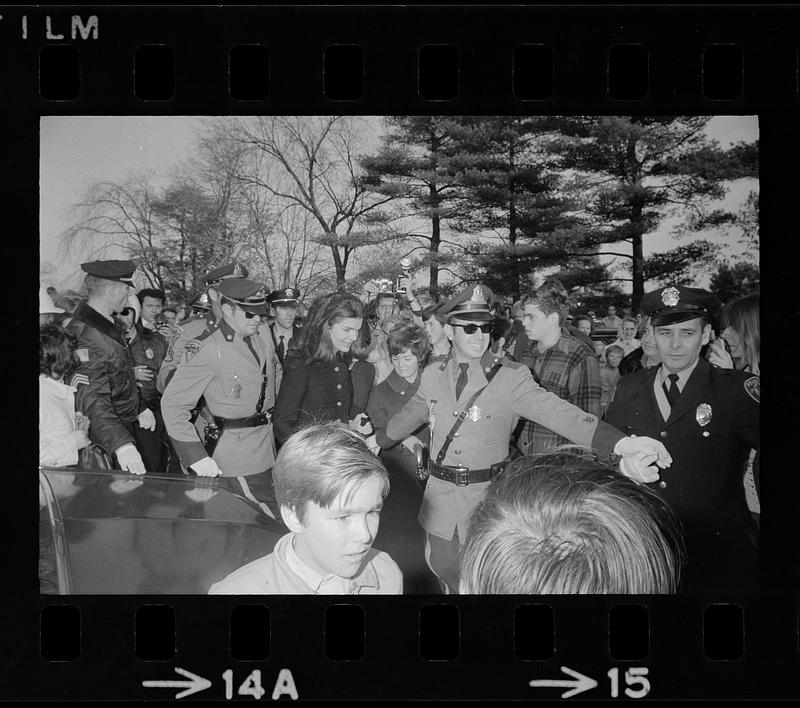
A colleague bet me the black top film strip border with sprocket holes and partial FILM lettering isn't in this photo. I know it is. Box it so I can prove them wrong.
[0,6,800,109]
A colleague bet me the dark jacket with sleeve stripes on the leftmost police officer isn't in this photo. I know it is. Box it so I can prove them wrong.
[66,302,140,453]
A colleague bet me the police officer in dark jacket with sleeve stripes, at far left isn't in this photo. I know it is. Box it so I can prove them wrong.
[66,260,156,474]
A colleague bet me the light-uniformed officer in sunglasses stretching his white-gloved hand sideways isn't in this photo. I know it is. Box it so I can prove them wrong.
[381,285,670,592]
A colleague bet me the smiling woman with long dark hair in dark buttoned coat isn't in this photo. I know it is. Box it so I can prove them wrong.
[273,292,375,445]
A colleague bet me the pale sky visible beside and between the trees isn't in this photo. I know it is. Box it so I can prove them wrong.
[39,116,758,289]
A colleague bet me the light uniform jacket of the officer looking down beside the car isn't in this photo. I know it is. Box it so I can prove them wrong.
[161,320,276,477]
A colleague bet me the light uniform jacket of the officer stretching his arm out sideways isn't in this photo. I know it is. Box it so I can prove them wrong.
[386,351,624,541]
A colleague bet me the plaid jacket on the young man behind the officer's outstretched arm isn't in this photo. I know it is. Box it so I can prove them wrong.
[514,327,602,454]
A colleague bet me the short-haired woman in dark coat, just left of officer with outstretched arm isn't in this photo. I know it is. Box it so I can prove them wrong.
[367,322,439,594]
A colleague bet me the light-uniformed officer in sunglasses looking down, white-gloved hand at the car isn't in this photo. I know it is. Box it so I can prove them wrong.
[161,278,277,517]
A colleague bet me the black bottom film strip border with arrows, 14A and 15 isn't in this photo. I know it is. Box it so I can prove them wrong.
[25,597,800,700]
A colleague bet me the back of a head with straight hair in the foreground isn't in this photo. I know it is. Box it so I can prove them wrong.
[460,448,684,595]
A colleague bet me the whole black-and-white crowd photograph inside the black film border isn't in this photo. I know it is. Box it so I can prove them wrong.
[39,115,762,596]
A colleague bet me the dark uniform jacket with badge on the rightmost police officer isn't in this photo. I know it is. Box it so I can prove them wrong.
[606,358,759,592]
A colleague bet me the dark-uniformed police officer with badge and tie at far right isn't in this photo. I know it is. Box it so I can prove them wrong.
[606,285,760,593]
